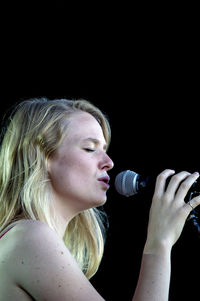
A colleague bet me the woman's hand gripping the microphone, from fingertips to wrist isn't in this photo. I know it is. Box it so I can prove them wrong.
[144,169,200,254]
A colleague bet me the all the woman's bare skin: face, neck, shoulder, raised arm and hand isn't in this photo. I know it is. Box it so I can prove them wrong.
[0,113,200,301]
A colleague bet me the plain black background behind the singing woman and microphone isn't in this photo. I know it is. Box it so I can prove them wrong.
[1,3,200,301]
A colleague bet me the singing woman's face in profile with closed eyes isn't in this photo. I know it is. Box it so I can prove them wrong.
[48,112,113,214]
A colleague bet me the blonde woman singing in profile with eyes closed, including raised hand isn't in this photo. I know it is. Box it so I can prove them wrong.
[0,98,200,301]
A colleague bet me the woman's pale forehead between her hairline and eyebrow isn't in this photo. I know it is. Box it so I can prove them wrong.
[67,112,105,143]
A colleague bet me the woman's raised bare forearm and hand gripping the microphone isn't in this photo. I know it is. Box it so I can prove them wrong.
[132,170,200,301]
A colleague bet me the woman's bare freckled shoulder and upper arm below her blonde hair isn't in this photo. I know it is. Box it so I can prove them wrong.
[6,221,103,301]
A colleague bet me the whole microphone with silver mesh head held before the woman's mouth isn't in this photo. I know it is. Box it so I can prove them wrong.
[115,170,200,197]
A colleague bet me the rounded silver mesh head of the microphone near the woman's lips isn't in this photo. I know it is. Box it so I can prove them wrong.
[115,170,139,197]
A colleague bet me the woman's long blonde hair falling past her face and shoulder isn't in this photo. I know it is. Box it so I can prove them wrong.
[0,98,110,278]
